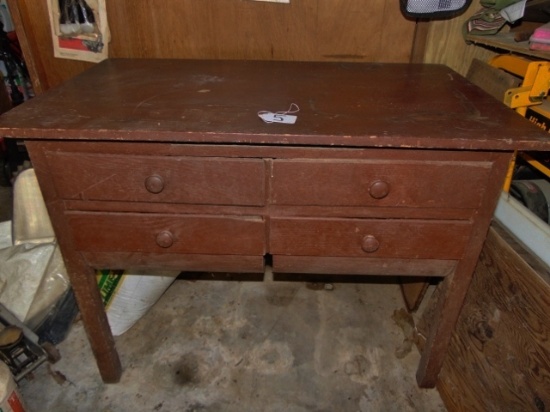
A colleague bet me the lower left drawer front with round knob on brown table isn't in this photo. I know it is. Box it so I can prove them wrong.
[66,212,265,255]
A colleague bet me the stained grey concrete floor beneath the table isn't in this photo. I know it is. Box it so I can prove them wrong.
[0,188,445,412]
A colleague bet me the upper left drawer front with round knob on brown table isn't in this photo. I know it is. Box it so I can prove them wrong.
[47,152,265,206]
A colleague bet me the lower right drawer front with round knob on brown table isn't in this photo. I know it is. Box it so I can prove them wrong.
[269,219,471,259]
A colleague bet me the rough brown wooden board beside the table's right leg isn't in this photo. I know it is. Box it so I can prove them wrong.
[437,224,550,411]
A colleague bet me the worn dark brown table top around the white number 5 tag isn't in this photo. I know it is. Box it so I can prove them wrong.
[0,59,550,150]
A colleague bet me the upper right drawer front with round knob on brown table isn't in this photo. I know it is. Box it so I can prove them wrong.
[271,160,491,208]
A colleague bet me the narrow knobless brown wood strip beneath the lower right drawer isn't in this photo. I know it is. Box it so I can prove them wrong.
[273,255,456,276]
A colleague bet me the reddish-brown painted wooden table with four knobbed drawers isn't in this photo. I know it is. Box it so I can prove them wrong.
[0,60,550,387]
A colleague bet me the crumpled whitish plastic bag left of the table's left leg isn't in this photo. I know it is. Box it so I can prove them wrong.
[0,169,70,329]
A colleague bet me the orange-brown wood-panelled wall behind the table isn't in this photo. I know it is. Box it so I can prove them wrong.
[8,0,415,93]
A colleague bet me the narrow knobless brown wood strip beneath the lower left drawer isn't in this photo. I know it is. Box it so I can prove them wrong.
[82,252,264,273]
